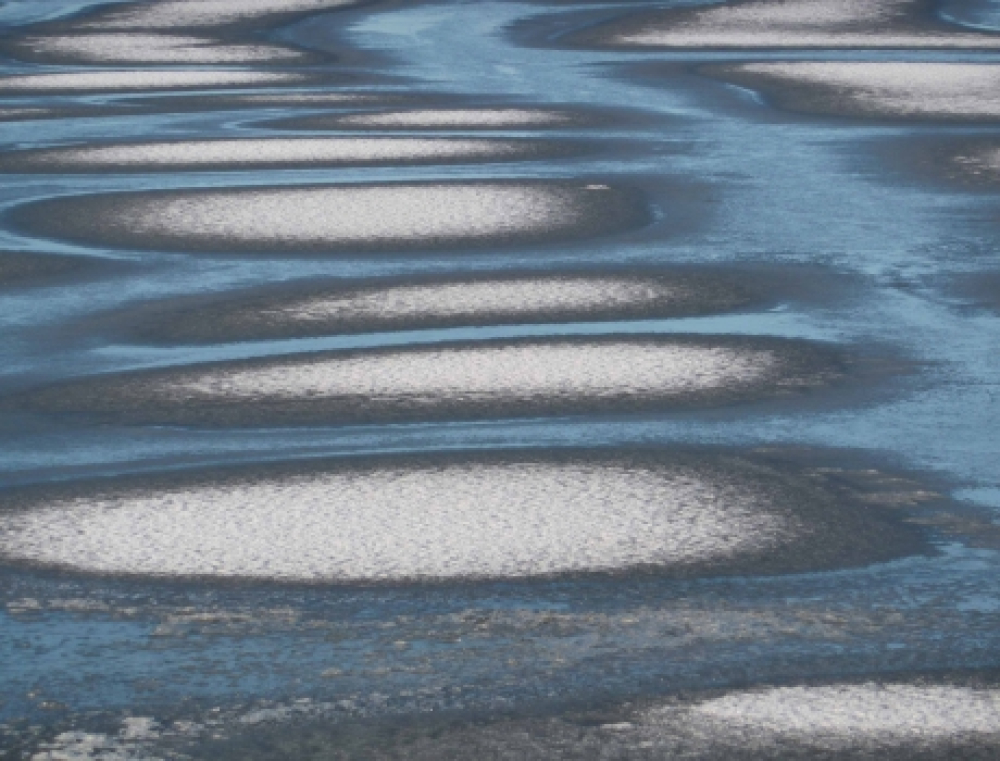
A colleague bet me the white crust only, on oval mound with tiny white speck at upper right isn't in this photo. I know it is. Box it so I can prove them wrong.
[113,183,620,246]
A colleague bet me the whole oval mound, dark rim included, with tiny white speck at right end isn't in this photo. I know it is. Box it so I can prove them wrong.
[12,179,650,254]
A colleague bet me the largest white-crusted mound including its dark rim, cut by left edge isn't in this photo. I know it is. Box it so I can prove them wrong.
[0,448,928,583]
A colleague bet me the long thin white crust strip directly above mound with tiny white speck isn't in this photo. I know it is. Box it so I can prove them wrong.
[17,138,525,169]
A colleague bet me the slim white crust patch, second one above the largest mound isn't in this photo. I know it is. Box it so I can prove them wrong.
[278,277,685,322]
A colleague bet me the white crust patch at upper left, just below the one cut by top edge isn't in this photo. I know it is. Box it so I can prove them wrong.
[19,34,302,64]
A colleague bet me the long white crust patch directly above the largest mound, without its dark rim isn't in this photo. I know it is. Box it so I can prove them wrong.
[170,343,779,409]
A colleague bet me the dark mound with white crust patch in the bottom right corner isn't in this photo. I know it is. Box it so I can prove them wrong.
[182,670,1000,761]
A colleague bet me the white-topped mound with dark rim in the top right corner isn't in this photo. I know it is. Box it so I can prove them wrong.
[574,0,1000,50]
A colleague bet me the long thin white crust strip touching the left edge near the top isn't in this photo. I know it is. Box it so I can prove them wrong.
[0,69,303,92]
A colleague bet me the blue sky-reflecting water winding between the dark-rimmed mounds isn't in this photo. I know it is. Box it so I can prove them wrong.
[0,0,1000,732]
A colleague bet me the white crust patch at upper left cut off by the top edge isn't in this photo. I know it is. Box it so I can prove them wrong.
[82,0,359,29]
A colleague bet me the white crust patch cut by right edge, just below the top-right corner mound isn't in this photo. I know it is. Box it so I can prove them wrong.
[733,61,1000,118]
